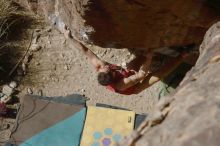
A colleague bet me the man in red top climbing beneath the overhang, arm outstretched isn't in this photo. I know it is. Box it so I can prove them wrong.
[64,27,191,95]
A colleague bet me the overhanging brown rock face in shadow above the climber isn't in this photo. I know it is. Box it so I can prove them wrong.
[17,0,219,49]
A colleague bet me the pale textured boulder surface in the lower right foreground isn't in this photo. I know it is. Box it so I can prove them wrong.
[123,22,220,146]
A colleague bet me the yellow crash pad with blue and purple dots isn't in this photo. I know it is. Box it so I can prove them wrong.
[80,106,135,146]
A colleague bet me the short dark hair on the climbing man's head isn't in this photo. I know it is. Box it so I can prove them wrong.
[98,72,113,86]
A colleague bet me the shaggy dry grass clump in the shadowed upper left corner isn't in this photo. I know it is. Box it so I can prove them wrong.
[0,0,38,81]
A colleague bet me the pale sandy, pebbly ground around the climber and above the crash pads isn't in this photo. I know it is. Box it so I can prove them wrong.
[19,24,164,113]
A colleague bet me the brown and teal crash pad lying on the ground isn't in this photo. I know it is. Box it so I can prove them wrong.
[11,95,86,146]
